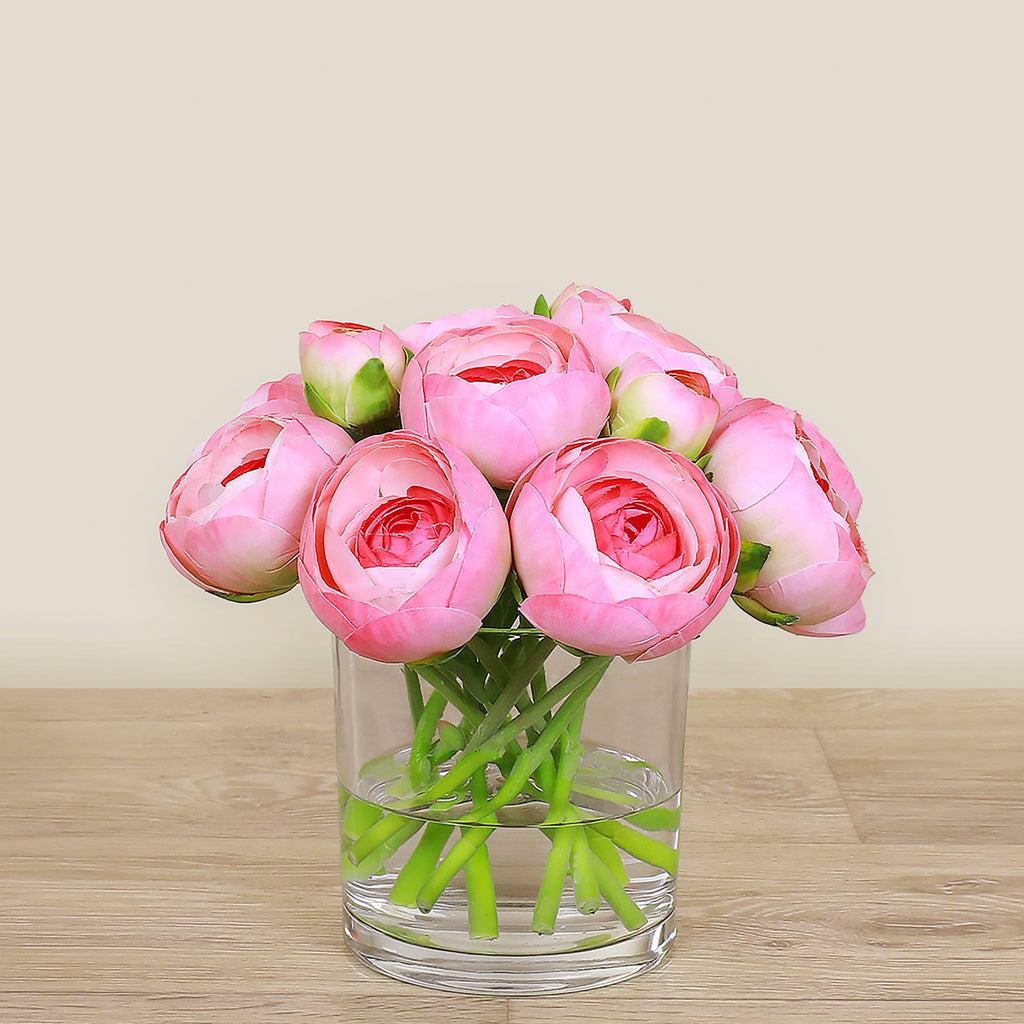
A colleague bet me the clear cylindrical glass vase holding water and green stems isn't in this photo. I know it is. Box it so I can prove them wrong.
[335,630,689,995]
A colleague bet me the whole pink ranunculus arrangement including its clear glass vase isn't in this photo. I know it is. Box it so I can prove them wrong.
[161,286,870,992]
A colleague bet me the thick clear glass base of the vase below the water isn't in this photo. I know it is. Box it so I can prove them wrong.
[345,913,676,996]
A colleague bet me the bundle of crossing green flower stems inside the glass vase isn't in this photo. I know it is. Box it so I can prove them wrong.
[343,631,678,940]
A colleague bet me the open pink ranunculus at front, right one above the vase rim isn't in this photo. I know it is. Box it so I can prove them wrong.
[509,437,739,660]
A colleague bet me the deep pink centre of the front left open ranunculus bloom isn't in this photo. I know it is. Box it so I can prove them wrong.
[352,487,455,568]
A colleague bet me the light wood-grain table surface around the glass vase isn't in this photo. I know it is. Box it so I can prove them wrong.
[0,689,1024,1024]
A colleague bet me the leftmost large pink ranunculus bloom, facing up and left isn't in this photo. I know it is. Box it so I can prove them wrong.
[160,414,352,600]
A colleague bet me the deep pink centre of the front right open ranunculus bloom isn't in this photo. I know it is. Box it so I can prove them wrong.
[580,479,684,580]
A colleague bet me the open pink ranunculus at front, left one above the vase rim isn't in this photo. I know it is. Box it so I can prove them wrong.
[299,430,511,663]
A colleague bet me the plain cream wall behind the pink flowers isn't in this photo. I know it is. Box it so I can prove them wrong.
[0,0,1024,686]
